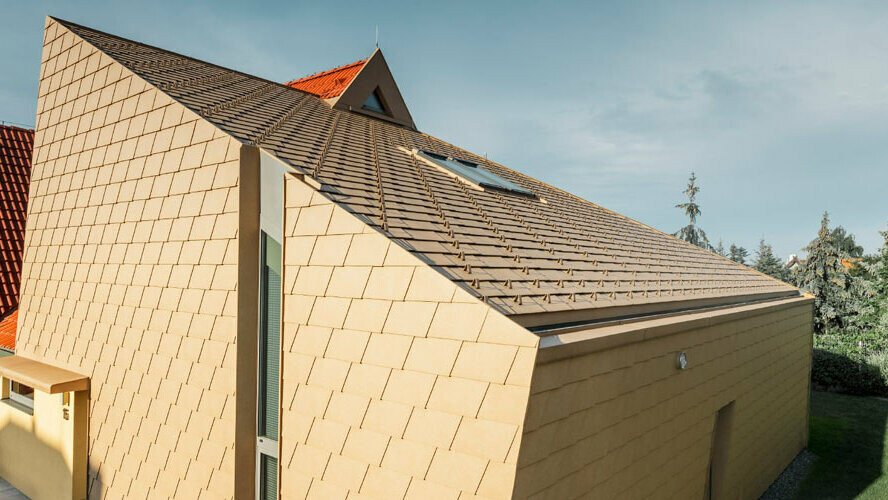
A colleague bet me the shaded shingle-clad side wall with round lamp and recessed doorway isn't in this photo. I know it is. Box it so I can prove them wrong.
[515,298,812,499]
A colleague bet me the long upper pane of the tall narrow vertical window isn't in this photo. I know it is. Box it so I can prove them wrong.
[259,234,281,440]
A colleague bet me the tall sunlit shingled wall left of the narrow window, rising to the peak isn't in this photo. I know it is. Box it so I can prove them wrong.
[17,20,239,499]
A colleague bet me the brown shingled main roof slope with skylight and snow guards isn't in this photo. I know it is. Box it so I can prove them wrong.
[59,21,798,325]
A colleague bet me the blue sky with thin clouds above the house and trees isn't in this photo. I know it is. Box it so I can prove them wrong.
[0,0,888,257]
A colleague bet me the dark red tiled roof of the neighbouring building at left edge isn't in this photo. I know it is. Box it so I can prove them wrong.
[0,125,34,340]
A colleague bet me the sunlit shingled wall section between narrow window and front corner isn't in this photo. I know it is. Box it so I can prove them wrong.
[280,177,539,499]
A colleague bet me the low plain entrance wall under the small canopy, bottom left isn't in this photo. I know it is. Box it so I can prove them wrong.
[0,378,89,500]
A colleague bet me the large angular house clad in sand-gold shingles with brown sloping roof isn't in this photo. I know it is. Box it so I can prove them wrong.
[0,18,812,499]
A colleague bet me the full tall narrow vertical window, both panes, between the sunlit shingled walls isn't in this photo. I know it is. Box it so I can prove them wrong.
[256,233,281,499]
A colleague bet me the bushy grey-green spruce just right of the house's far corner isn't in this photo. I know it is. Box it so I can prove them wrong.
[799,212,866,333]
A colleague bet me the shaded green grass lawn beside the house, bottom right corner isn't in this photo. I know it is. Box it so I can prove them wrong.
[797,392,888,499]
